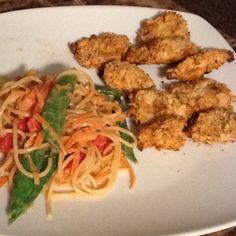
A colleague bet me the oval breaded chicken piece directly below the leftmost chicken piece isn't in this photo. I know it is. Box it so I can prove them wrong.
[103,60,155,92]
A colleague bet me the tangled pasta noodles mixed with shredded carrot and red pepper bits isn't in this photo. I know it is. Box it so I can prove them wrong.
[0,69,136,218]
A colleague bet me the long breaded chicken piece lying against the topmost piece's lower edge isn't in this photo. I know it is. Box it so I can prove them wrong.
[126,37,199,64]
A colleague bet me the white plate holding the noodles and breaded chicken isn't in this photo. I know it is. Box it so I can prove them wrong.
[0,6,236,236]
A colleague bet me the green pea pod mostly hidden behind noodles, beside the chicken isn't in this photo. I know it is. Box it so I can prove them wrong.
[96,86,137,162]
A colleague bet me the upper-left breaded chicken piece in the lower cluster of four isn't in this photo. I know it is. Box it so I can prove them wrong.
[129,89,190,124]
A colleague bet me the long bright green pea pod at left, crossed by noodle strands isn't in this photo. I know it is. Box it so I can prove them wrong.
[8,75,76,223]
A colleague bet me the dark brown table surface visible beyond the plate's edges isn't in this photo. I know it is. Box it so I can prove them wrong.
[0,0,236,236]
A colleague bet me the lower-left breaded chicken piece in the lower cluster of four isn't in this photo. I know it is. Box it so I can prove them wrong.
[138,117,186,150]
